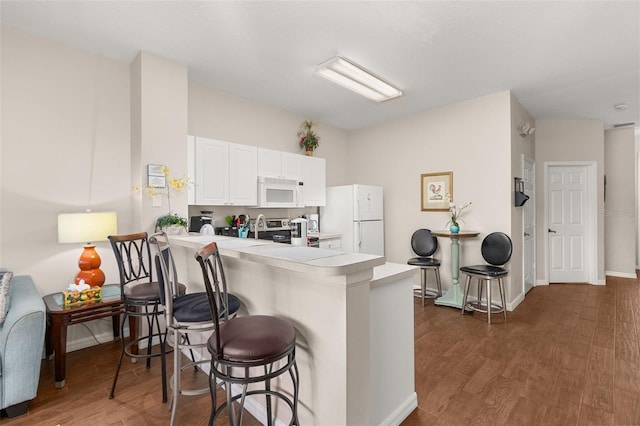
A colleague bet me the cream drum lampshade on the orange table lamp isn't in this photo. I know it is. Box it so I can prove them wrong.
[58,212,118,243]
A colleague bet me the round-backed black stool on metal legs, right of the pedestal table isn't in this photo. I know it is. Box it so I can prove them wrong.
[460,232,513,324]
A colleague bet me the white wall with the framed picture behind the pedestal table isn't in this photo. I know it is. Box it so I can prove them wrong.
[347,91,521,300]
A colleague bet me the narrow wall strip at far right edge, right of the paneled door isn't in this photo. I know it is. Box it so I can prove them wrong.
[604,128,637,278]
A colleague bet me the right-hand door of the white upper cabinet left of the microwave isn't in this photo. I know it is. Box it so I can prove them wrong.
[228,143,258,206]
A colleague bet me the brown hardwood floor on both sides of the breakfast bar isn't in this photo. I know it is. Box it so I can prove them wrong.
[2,278,640,426]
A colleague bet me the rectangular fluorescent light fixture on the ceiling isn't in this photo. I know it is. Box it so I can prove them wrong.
[315,56,402,102]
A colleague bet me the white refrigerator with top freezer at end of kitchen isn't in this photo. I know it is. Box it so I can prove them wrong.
[319,185,384,256]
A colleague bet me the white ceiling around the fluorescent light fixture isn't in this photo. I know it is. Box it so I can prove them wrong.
[0,0,640,130]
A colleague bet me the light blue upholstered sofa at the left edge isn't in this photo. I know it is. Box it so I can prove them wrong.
[0,275,46,417]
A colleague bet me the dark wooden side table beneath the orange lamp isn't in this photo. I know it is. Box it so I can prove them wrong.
[42,284,125,389]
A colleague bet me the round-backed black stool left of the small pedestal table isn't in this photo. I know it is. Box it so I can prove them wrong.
[407,229,442,306]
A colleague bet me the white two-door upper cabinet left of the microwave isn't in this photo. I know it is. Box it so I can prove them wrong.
[189,137,258,206]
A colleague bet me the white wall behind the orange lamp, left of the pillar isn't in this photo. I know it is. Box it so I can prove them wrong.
[0,27,131,348]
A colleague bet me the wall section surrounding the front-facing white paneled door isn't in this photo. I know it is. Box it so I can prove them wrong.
[536,120,605,284]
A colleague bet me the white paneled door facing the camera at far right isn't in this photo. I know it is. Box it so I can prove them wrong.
[547,165,592,282]
